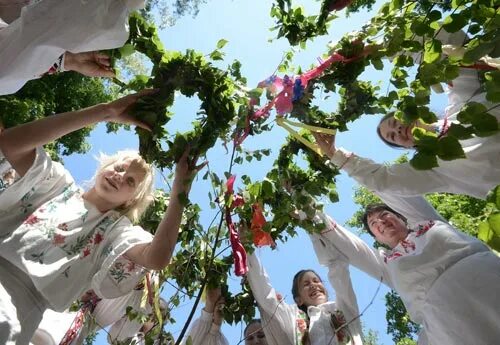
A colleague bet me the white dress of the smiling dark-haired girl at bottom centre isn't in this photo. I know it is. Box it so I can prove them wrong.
[247,253,362,345]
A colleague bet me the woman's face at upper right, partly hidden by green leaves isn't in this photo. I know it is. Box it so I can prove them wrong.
[377,112,415,148]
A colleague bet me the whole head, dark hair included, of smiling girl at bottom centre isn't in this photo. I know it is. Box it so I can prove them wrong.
[292,270,328,311]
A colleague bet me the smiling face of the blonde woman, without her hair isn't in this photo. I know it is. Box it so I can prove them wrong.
[95,158,146,208]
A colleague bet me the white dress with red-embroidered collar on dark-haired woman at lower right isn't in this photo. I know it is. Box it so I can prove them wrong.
[315,198,500,345]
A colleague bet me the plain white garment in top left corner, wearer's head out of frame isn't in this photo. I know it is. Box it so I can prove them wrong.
[0,0,144,95]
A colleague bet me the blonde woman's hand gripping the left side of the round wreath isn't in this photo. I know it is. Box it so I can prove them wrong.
[104,89,157,131]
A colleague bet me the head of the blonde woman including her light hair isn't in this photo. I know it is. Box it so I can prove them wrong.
[94,150,154,222]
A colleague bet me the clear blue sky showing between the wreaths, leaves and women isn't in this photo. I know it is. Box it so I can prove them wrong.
[65,0,450,345]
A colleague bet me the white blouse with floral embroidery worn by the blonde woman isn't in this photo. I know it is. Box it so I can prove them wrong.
[0,148,152,344]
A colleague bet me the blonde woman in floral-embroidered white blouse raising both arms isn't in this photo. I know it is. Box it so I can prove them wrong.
[0,90,201,345]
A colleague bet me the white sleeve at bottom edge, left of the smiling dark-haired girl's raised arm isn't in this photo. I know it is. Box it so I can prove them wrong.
[183,309,229,345]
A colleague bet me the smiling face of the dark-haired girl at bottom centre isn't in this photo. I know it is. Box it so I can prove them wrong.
[295,271,328,307]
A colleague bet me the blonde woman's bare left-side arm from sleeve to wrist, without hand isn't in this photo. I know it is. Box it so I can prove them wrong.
[0,104,107,176]
